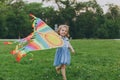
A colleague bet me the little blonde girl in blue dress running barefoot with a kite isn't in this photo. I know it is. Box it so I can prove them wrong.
[54,25,75,80]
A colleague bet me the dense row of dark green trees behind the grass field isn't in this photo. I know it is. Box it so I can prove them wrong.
[0,0,120,39]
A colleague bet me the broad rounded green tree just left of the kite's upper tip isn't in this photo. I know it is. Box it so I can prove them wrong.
[5,0,32,38]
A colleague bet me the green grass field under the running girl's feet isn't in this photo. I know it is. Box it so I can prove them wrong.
[0,40,120,80]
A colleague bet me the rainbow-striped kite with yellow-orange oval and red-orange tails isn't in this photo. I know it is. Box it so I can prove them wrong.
[11,14,63,62]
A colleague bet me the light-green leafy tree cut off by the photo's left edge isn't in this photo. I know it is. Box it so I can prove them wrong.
[0,0,13,38]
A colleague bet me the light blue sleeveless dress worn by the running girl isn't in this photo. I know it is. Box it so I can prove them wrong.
[54,37,71,66]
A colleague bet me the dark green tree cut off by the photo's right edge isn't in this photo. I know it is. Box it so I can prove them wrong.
[105,4,120,38]
